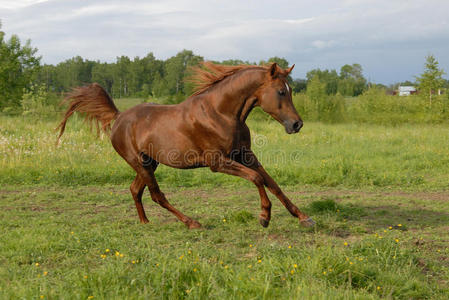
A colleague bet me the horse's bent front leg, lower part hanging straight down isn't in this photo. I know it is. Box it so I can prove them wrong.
[210,157,271,227]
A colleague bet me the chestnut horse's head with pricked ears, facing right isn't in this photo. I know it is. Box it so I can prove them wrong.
[256,63,303,134]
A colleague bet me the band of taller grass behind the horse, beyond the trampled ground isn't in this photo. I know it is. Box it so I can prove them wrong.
[0,116,449,189]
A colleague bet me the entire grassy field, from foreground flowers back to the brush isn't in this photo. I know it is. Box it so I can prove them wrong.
[0,100,449,299]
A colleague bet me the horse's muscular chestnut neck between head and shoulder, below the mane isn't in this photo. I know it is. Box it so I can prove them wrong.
[212,69,264,122]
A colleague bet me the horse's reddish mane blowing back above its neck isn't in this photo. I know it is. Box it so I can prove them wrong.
[188,61,269,96]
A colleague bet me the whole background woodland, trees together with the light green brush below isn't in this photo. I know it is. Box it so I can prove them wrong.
[0,23,449,124]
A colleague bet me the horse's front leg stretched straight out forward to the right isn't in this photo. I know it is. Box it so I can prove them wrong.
[241,150,315,227]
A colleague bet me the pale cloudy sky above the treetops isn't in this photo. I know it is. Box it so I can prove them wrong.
[0,0,449,84]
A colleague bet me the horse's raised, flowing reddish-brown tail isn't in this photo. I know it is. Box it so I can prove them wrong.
[56,83,120,144]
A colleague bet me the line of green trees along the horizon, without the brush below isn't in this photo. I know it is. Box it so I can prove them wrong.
[0,23,448,109]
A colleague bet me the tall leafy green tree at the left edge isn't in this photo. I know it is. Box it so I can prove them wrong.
[0,23,41,108]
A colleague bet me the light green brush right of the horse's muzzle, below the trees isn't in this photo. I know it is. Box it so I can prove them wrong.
[293,88,449,125]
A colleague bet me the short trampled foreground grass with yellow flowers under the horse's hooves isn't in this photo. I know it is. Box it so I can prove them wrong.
[0,186,449,299]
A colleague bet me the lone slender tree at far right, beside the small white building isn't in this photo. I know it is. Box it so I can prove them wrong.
[416,55,445,105]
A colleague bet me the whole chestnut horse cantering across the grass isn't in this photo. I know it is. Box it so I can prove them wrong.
[58,62,315,228]
